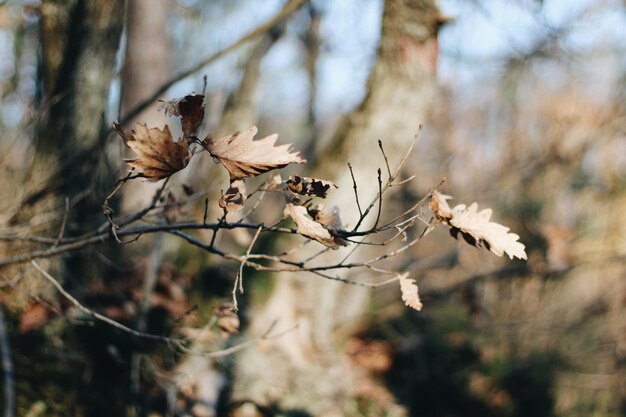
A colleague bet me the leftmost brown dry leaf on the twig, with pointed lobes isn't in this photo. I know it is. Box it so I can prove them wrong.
[113,122,189,181]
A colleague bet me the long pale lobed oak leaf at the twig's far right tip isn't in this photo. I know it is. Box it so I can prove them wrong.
[429,192,527,259]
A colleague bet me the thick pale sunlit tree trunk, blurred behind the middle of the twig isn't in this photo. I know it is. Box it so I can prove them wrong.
[233,0,442,416]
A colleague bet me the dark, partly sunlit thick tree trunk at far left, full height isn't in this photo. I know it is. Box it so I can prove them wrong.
[13,0,128,416]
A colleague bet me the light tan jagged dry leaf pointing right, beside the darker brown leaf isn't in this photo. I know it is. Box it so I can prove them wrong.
[203,126,306,180]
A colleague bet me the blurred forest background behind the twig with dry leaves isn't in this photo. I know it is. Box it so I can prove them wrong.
[0,0,626,417]
